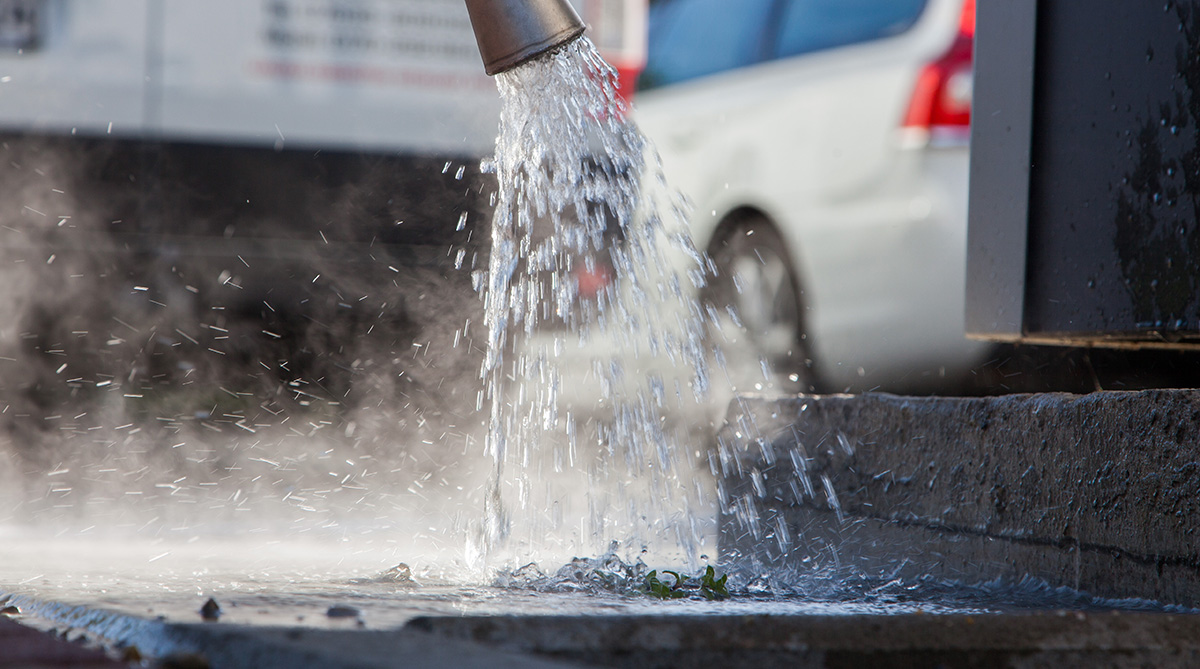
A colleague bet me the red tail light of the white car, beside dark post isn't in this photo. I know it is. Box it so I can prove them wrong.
[904,0,976,134]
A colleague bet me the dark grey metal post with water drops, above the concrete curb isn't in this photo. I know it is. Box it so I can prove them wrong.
[967,0,1200,349]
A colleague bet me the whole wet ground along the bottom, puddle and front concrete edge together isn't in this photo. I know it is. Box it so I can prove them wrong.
[0,534,1200,668]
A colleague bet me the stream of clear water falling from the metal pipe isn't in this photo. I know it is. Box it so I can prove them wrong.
[468,38,713,570]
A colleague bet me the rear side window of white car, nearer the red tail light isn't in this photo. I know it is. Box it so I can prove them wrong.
[773,0,926,58]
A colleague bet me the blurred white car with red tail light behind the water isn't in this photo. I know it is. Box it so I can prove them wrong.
[634,0,988,392]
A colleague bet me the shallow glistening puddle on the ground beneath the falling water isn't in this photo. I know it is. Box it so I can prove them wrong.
[0,532,1180,641]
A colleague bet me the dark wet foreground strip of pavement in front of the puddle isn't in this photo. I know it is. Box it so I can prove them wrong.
[7,593,1200,668]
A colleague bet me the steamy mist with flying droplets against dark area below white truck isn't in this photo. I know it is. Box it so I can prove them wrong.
[0,131,499,565]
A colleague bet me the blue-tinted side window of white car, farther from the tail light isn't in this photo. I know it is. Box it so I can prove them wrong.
[637,0,772,90]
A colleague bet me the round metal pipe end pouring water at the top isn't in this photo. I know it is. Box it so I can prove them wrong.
[467,0,583,74]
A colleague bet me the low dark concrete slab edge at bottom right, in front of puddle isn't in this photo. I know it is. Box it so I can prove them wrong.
[409,611,1200,669]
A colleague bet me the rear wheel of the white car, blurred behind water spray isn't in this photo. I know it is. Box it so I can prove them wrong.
[707,216,814,392]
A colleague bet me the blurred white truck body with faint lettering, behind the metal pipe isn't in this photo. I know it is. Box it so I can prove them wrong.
[0,0,646,156]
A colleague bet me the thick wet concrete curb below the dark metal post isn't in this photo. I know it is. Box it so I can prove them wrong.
[714,391,1200,607]
